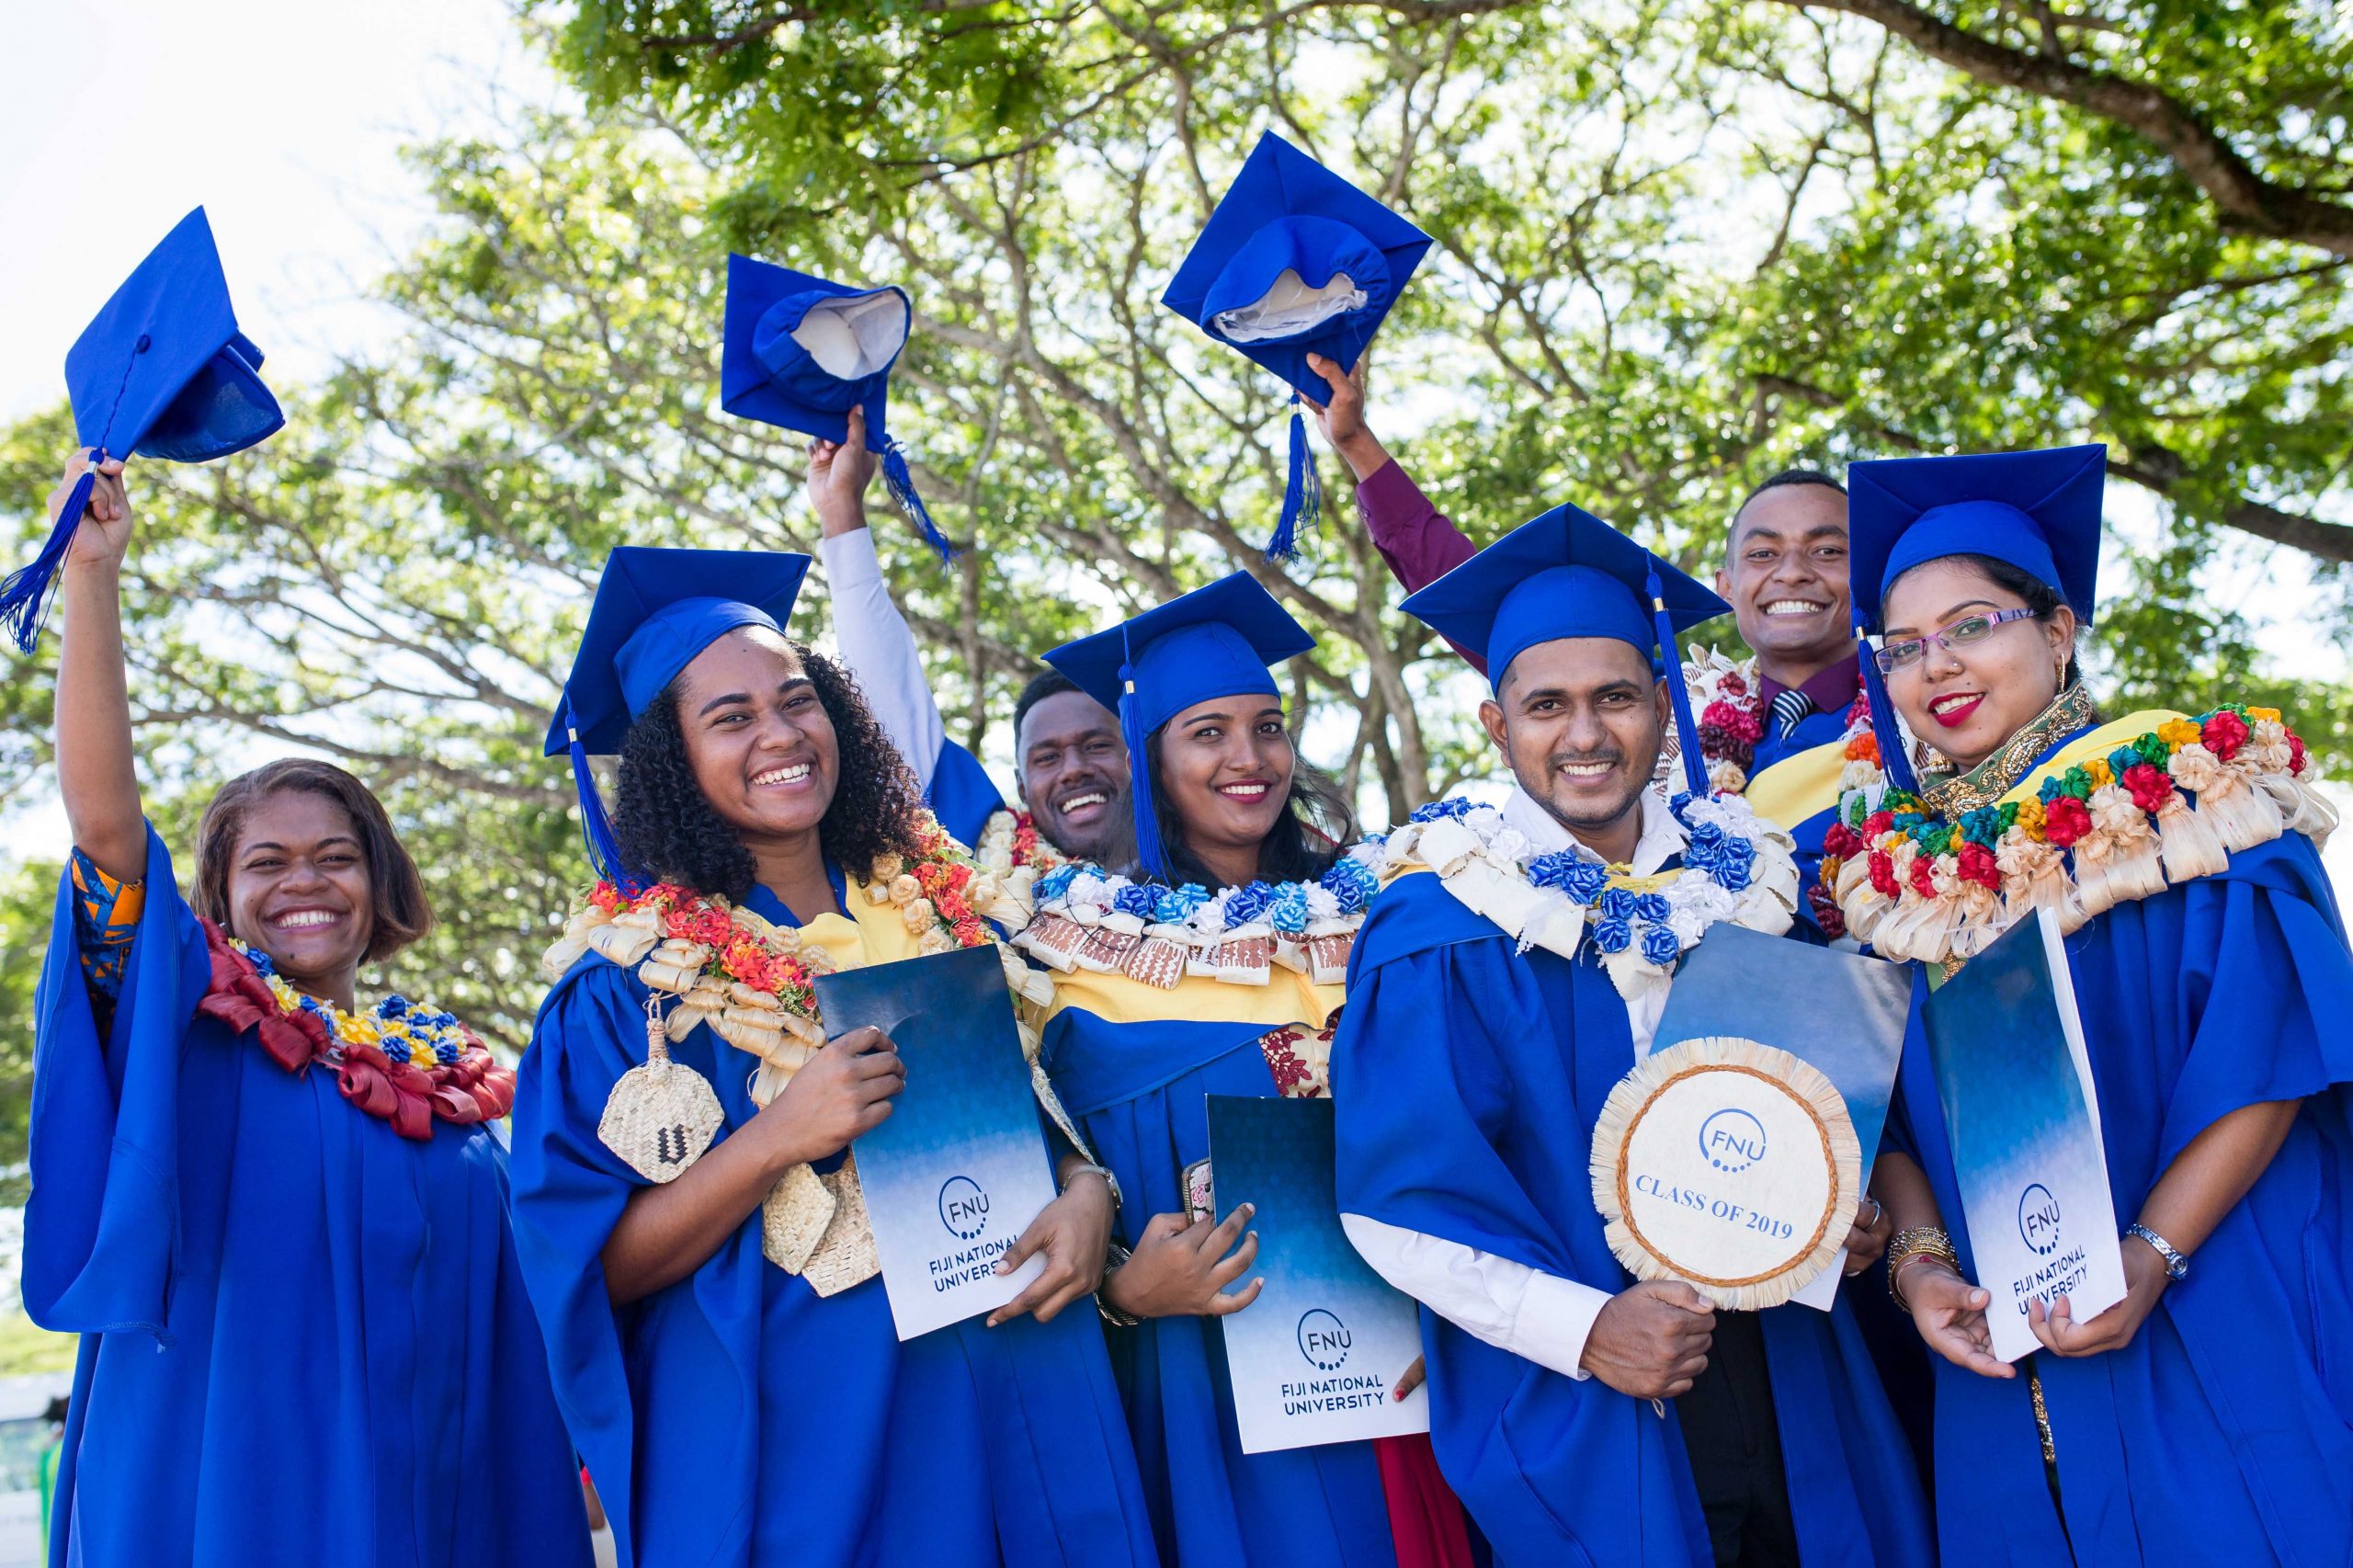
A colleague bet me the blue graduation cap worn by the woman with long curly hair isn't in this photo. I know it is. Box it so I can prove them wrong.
[546,544,810,881]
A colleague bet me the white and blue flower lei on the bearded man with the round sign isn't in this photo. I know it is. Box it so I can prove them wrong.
[1383,793,1798,1001]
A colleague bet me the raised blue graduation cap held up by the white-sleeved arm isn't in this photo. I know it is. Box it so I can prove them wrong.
[720,256,955,561]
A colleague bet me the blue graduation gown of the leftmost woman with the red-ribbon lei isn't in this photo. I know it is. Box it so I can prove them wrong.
[24,834,588,1568]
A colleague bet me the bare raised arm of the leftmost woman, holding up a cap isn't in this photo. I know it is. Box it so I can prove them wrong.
[50,452,146,883]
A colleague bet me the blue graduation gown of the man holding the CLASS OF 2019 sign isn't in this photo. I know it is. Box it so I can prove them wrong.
[1332,873,1932,1568]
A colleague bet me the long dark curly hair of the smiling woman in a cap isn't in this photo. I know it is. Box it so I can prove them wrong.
[612,642,923,902]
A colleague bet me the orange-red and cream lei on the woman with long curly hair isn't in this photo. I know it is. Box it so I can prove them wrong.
[541,822,1045,1104]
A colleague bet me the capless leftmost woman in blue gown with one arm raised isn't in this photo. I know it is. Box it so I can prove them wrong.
[24,452,588,1568]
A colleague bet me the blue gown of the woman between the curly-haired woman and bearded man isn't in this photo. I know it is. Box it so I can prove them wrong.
[1045,993,1403,1568]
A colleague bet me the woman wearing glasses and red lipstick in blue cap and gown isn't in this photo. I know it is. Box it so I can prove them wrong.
[1824,445,2353,1563]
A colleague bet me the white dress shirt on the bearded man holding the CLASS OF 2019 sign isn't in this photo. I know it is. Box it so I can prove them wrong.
[1339,787,1688,1380]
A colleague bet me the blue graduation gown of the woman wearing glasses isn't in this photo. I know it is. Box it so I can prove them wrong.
[1899,748,2353,1568]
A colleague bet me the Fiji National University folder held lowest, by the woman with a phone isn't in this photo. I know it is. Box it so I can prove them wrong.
[1205,1095,1430,1452]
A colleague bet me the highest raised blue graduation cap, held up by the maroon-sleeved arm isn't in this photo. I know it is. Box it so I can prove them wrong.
[1160,131,1430,561]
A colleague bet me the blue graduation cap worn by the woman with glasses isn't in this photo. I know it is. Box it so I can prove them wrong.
[1847,443,2109,791]
